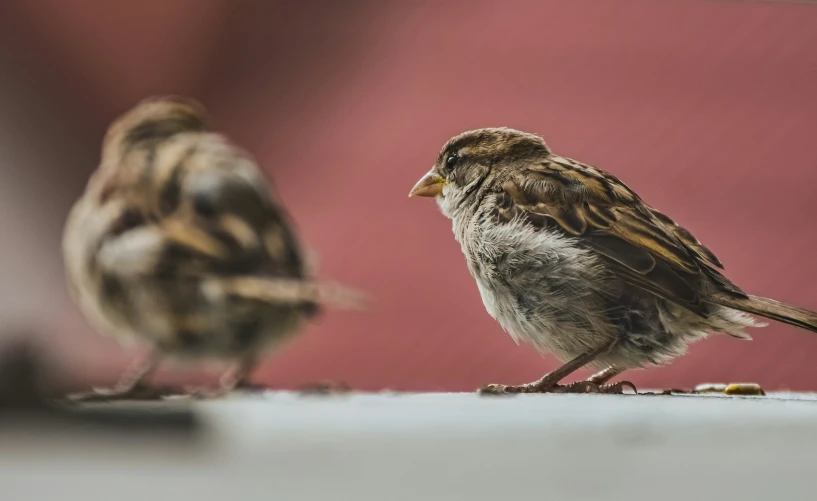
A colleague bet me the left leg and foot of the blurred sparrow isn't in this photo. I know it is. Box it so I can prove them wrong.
[69,349,173,402]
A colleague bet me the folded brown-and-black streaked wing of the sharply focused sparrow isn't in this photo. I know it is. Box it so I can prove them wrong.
[495,156,743,315]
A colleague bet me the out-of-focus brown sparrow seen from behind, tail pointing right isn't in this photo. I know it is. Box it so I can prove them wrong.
[62,96,358,398]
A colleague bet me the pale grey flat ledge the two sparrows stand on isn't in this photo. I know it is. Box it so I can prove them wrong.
[0,393,817,501]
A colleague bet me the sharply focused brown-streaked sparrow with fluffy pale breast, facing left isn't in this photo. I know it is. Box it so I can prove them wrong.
[409,128,817,394]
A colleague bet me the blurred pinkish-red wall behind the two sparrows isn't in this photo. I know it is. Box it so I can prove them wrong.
[0,0,817,390]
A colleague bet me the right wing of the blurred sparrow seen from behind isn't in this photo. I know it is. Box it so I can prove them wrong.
[151,134,304,278]
